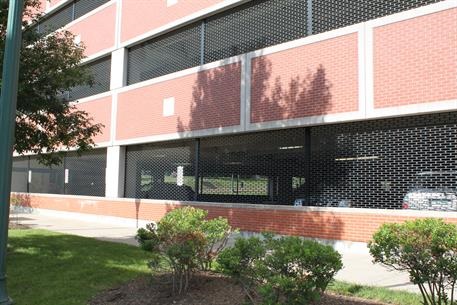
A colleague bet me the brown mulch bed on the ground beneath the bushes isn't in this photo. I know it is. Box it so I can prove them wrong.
[89,273,384,305]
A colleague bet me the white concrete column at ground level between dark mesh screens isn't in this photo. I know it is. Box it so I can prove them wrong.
[105,146,125,198]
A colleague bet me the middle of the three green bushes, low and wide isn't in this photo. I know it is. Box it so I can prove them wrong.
[217,236,342,305]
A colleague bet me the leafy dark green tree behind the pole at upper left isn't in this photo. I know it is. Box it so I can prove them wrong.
[0,0,103,165]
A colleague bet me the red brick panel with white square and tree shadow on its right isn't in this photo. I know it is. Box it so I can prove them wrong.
[116,63,241,140]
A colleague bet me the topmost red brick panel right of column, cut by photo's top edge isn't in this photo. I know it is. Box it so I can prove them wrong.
[121,0,223,42]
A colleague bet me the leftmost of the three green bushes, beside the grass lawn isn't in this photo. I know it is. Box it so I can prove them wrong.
[136,207,232,294]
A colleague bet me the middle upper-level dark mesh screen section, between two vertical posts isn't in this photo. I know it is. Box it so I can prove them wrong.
[205,0,307,63]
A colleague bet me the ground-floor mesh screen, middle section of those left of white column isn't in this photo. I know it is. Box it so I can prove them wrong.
[29,157,64,194]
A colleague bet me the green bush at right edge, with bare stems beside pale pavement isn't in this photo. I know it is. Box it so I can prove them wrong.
[368,218,457,305]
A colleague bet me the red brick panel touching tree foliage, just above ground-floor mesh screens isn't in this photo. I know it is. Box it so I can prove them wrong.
[77,96,111,143]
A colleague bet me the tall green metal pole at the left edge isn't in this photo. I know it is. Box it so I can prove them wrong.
[0,0,23,305]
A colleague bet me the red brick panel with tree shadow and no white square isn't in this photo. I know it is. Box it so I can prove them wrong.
[251,33,358,123]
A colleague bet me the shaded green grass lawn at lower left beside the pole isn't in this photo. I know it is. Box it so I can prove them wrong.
[7,230,149,305]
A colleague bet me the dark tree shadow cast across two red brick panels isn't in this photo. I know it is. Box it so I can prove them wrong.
[176,56,347,207]
